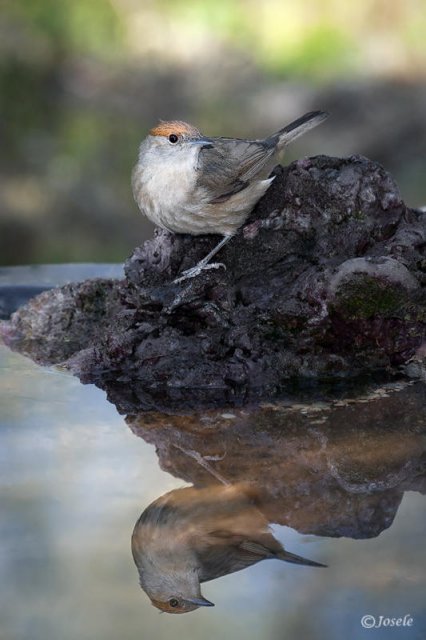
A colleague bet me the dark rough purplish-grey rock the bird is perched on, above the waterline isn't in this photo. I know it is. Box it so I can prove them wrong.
[2,156,426,408]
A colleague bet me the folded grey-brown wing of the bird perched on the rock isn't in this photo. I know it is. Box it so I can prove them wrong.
[196,138,276,203]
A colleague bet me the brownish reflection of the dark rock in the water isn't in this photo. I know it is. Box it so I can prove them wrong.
[126,383,426,538]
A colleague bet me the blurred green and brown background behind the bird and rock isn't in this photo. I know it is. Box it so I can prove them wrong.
[0,0,426,265]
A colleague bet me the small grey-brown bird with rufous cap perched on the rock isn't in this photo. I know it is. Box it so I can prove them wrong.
[132,111,329,283]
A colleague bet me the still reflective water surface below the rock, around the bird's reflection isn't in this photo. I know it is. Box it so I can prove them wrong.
[0,347,426,640]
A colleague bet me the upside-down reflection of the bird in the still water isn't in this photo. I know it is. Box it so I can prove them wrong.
[131,483,326,613]
